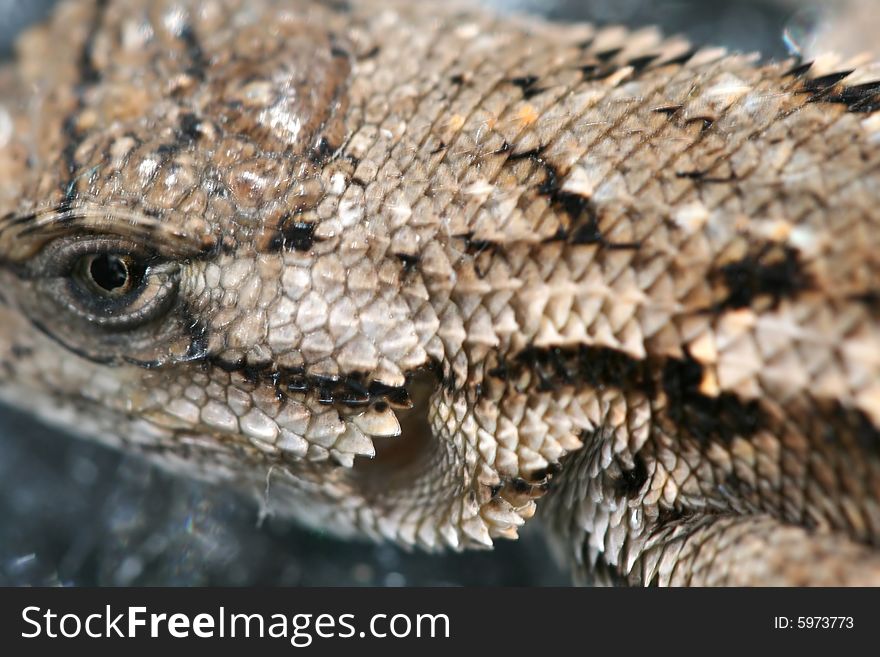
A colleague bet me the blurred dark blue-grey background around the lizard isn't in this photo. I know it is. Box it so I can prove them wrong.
[0,0,852,586]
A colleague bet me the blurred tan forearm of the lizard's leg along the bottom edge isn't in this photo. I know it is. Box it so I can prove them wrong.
[628,515,880,586]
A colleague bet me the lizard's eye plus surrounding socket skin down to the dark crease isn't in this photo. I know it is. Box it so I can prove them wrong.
[8,233,195,367]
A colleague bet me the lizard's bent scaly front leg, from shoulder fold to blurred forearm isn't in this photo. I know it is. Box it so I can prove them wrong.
[542,402,880,586]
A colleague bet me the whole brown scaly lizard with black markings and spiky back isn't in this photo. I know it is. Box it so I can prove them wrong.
[0,0,880,585]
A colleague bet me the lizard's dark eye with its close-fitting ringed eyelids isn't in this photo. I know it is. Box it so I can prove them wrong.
[36,236,178,331]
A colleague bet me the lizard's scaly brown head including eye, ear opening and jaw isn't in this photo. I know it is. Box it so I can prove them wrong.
[0,2,547,549]
